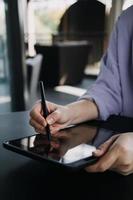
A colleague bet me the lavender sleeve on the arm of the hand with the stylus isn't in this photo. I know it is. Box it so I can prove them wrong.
[79,18,122,120]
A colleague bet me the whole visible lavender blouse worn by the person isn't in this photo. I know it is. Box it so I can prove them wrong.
[80,6,133,120]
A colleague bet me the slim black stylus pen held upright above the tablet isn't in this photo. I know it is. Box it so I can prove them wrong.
[39,81,51,142]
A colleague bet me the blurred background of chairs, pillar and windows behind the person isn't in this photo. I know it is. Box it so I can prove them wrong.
[0,0,133,113]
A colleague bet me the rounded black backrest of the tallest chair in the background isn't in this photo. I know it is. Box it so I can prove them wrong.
[58,0,105,36]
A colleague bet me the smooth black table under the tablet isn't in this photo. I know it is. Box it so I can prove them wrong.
[0,112,133,200]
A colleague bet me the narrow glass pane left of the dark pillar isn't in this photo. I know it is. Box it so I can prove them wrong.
[0,0,11,113]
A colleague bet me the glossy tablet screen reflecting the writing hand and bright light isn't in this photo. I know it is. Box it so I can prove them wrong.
[10,125,112,163]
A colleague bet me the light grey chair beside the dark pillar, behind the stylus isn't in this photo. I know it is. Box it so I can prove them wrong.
[26,54,43,105]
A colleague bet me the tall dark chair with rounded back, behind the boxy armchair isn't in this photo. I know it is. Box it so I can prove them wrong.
[53,0,105,63]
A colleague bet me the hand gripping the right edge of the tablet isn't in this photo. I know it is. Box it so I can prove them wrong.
[86,133,133,175]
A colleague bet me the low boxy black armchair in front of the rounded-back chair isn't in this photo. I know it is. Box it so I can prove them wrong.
[35,41,91,87]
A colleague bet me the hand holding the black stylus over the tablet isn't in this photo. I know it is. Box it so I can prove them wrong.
[29,102,71,133]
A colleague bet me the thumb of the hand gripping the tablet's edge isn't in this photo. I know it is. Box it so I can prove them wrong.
[93,134,119,157]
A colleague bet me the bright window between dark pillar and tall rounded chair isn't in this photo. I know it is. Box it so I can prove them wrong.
[28,0,76,54]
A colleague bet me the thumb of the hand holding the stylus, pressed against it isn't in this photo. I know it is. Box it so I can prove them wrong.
[46,110,61,125]
